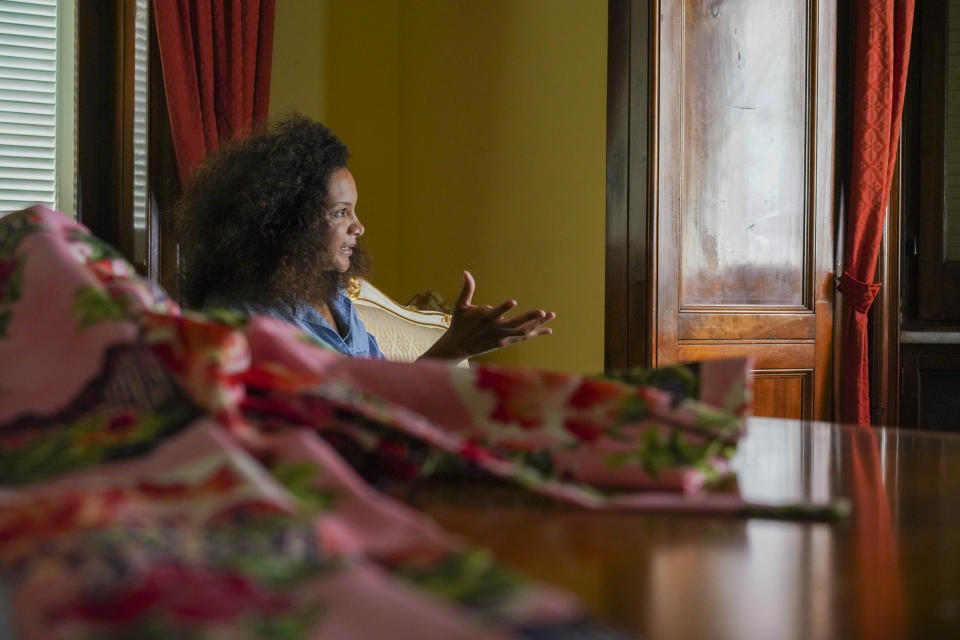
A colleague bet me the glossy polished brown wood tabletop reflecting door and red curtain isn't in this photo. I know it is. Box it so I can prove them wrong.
[412,418,960,640]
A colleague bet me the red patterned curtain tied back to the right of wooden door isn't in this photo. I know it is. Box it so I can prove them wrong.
[839,0,914,425]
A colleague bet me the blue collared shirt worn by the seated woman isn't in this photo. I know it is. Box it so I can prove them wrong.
[203,291,384,360]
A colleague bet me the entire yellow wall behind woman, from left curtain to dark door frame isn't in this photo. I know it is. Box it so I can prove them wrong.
[271,0,607,371]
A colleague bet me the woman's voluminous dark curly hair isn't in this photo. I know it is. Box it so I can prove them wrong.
[175,114,369,307]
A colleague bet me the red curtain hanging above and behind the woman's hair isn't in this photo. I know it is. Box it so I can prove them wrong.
[153,0,274,180]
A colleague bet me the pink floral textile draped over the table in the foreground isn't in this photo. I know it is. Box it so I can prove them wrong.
[0,206,750,639]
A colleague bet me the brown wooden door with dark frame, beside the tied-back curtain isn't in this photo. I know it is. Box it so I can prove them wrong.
[607,0,836,419]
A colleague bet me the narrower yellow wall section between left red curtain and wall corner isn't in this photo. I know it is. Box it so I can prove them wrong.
[270,0,404,302]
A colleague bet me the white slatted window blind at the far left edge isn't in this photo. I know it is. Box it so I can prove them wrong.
[0,0,73,215]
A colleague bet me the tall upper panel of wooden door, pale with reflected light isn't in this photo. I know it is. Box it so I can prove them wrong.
[666,0,811,309]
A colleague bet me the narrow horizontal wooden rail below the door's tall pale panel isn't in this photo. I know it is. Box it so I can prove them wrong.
[678,312,816,340]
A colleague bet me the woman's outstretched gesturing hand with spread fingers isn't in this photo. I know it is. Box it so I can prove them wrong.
[423,271,556,360]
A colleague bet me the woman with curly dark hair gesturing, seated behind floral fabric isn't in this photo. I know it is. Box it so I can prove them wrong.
[178,115,554,360]
